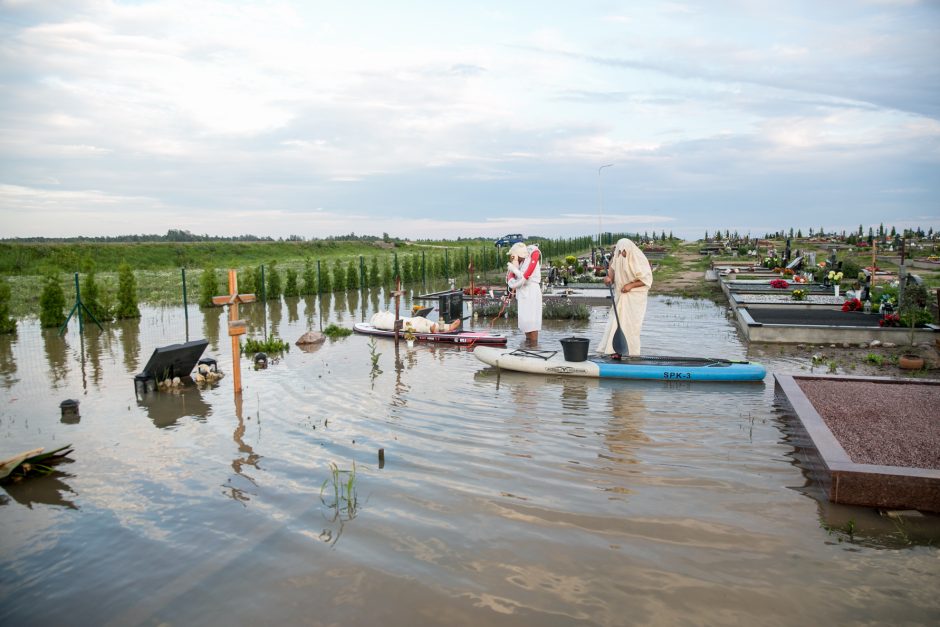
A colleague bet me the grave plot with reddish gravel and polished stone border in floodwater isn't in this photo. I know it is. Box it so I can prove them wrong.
[775,374,940,512]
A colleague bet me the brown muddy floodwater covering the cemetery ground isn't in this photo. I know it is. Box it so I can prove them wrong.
[0,292,940,625]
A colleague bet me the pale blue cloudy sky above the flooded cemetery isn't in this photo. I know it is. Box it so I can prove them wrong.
[0,0,940,237]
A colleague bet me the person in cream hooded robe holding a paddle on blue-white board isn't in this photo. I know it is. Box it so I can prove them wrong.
[599,238,653,359]
